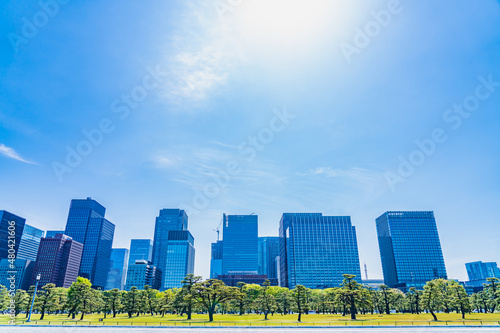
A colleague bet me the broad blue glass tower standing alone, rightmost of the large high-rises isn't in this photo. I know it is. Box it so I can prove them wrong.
[376,211,447,291]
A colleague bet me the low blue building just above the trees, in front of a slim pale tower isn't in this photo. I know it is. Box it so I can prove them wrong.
[125,260,161,291]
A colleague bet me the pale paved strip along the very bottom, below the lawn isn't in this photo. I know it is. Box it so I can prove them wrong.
[0,326,500,333]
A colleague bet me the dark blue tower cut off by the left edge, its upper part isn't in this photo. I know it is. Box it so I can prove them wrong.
[0,210,26,259]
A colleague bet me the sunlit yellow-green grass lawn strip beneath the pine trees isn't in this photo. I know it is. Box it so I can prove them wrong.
[0,313,500,326]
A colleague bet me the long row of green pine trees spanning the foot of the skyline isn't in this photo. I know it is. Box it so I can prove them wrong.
[0,274,500,321]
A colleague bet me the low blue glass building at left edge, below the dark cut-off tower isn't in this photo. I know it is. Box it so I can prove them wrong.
[0,259,35,290]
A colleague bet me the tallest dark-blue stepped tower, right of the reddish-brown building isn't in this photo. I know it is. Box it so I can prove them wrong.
[64,198,115,289]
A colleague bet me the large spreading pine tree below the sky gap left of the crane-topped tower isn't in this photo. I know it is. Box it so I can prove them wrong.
[192,279,243,321]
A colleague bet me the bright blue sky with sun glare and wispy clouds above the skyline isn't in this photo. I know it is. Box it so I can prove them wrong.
[0,0,500,280]
